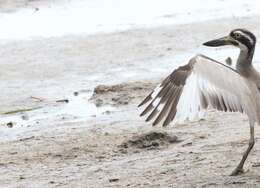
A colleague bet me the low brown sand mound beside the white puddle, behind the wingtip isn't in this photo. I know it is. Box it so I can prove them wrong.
[90,82,156,107]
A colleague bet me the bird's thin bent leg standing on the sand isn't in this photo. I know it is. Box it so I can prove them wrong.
[231,121,255,176]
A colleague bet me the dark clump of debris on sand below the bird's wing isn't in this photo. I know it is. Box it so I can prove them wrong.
[119,131,180,153]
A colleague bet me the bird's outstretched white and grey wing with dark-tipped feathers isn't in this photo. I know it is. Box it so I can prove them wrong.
[139,55,250,126]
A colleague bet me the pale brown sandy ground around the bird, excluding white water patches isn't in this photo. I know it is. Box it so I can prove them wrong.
[0,16,260,188]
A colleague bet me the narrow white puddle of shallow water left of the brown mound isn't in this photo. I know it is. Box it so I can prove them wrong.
[0,92,116,140]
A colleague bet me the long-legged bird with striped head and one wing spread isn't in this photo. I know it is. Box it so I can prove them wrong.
[139,28,260,176]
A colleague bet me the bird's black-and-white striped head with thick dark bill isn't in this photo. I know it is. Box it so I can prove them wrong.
[203,29,256,52]
